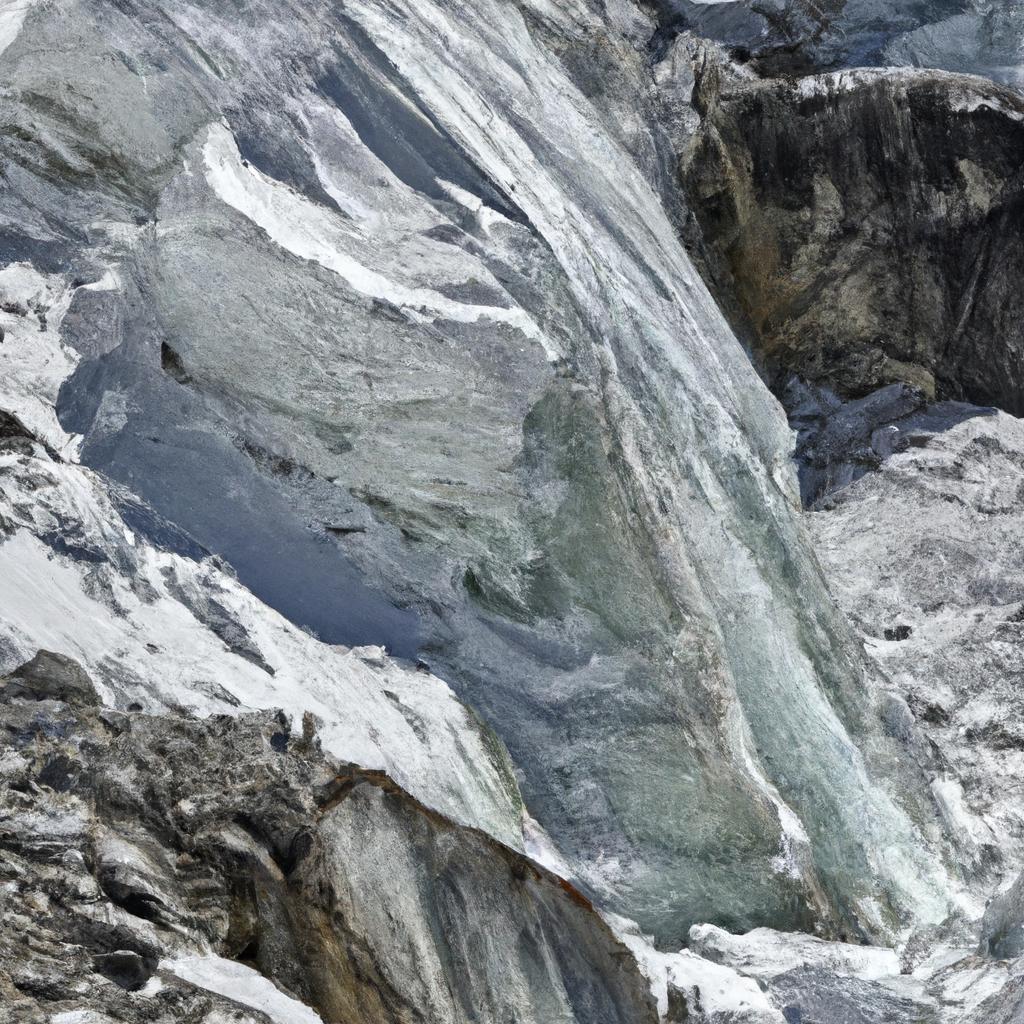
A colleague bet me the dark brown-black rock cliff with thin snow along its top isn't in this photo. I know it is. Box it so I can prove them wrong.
[683,64,1024,414]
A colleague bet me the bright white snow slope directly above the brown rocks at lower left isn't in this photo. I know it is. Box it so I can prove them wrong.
[0,440,521,847]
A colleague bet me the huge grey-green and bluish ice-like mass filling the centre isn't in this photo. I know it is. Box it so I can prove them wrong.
[0,0,950,947]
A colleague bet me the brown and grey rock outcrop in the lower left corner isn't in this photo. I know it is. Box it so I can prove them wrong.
[0,657,656,1024]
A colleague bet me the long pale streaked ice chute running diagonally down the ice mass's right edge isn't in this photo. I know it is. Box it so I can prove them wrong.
[339,0,948,931]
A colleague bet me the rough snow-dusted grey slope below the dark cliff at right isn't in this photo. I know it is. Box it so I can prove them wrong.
[809,413,1024,892]
